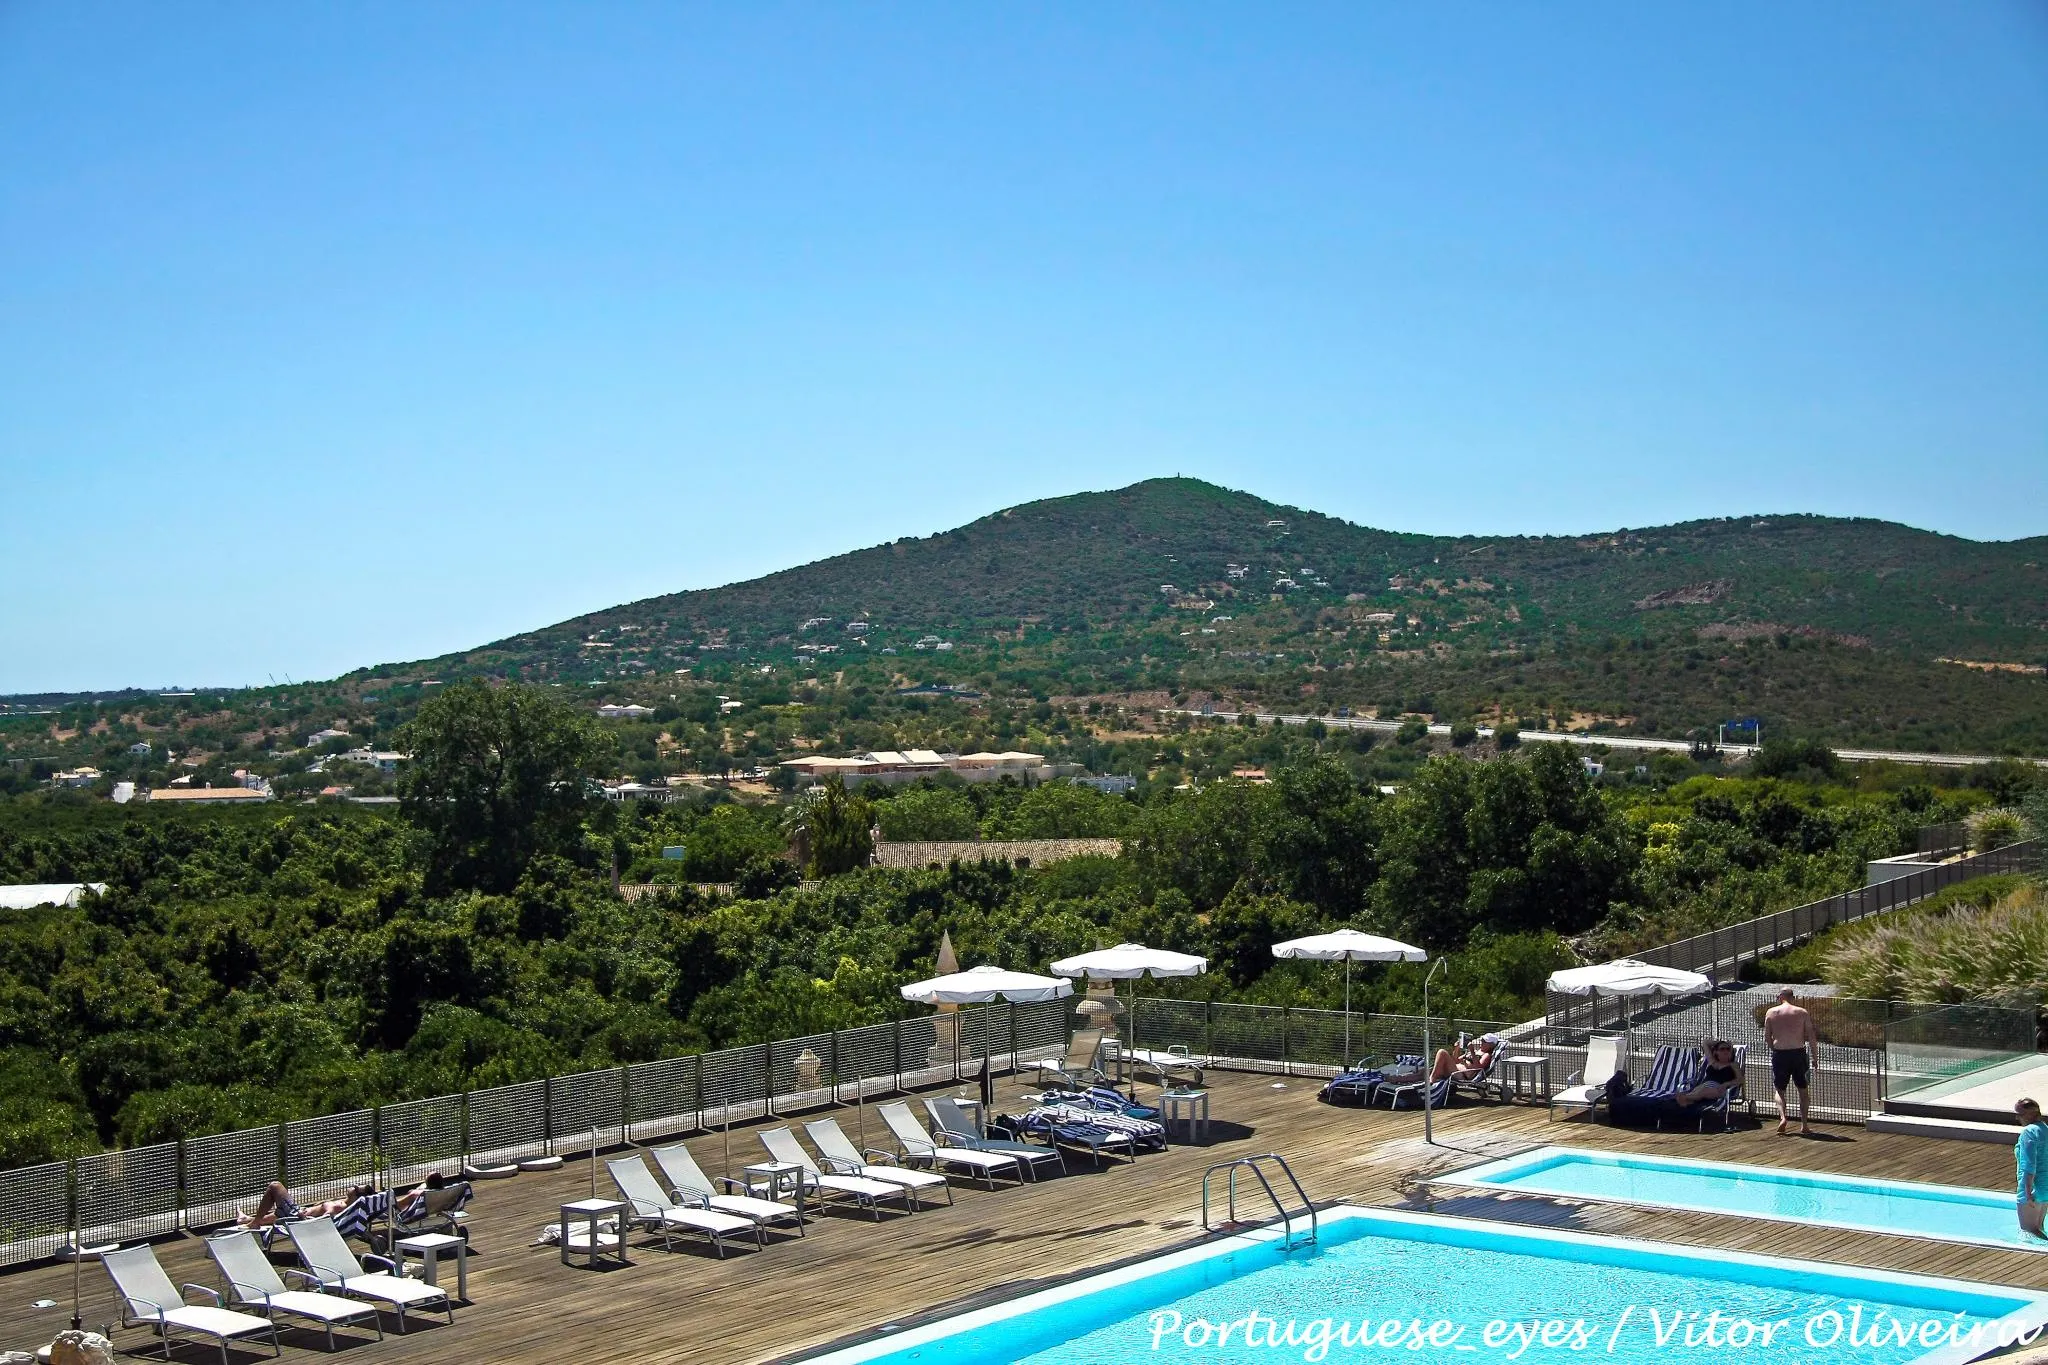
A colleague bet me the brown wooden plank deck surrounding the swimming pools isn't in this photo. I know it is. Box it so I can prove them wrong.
[0,1074,2048,1365]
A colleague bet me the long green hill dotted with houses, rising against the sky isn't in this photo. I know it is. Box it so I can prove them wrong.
[452,479,2048,665]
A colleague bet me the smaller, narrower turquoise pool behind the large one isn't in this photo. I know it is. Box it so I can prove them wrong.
[1438,1130,2048,1250]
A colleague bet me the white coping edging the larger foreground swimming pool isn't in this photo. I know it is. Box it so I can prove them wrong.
[797,1185,2048,1365]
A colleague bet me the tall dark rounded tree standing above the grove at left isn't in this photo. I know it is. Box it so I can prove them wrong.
[397,681,612,892]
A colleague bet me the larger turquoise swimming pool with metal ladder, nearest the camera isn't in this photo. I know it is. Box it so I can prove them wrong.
[794,1207,2048,1365]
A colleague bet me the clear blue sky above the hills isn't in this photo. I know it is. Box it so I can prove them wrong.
[0,0,2048,692]
